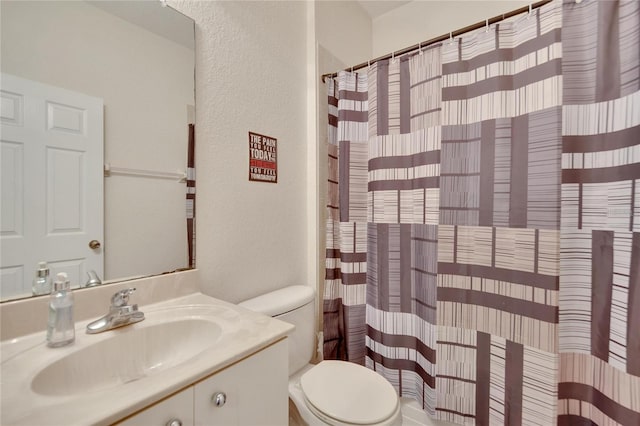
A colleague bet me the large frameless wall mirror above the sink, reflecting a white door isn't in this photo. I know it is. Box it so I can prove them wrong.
[0,0,195,300]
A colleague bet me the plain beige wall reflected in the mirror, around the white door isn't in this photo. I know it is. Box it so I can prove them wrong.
[1,1,194,285]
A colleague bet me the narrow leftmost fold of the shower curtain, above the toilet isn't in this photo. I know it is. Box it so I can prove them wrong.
[323,73,368,364]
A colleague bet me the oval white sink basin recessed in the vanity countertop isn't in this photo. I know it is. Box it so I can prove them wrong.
[31,319,222,395]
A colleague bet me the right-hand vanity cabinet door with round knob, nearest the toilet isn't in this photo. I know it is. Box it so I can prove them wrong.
[194,339,289,426]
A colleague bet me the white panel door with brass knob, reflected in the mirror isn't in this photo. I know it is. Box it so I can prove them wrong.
[0,73,104,299]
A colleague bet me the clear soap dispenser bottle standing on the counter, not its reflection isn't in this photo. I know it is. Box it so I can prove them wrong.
[47,272,76,348]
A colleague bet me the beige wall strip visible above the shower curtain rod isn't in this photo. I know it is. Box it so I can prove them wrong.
[372,0,530,58]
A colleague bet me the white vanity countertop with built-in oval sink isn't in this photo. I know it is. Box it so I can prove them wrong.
[0,293,293,426]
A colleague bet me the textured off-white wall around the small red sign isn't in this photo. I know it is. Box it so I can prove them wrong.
[170,0,308,302]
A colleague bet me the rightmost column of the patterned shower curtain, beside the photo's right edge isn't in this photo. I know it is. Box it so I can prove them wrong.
[558,1,640,425]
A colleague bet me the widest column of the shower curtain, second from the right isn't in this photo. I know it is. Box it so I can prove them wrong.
[436,3,562,425]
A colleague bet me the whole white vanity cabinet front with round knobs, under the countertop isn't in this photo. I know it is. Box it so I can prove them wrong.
[118,339,289,426]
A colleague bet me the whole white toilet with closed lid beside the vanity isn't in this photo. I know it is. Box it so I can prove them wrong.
[239,285,402,426]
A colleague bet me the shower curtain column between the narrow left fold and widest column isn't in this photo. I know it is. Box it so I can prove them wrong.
[365,46,442,413]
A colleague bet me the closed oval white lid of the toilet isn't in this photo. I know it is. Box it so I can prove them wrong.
[300,361,398,424]
